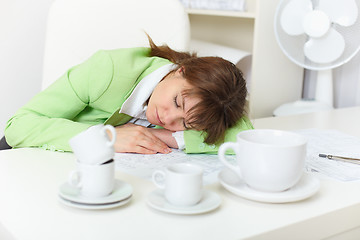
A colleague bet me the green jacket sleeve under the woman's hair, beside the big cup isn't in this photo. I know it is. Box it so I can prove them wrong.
[184,117,254,154]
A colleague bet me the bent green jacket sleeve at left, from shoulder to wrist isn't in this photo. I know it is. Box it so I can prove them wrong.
[5,51,113,151]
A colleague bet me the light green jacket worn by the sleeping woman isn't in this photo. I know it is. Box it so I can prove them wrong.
[5,48,253,153]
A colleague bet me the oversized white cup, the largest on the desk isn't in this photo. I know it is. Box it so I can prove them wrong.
[218,129,307,192]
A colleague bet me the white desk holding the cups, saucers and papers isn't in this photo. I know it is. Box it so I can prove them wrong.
[0,107,360,240]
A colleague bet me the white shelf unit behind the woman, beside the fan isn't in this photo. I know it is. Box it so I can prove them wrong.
[187,0,303,118]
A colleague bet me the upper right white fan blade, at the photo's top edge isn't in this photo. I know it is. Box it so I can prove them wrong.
[319,0,358,27]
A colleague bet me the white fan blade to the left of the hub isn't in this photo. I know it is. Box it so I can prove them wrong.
[280,0,313,36]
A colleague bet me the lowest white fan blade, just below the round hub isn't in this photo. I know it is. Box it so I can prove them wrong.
[304,28,345,63]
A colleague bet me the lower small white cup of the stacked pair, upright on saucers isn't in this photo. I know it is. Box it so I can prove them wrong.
[68,159,115,198]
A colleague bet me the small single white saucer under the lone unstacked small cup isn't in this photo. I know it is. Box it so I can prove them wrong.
[147,189,221,215]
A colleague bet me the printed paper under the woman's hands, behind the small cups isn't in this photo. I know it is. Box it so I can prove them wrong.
[115,149,235,184]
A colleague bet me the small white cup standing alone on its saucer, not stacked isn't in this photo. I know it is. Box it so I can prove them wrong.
[152,163,203,206]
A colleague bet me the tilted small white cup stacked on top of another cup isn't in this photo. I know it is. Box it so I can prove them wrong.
[69,124,116,164]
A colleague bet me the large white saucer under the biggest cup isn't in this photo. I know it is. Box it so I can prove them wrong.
[219,168,320,203]
